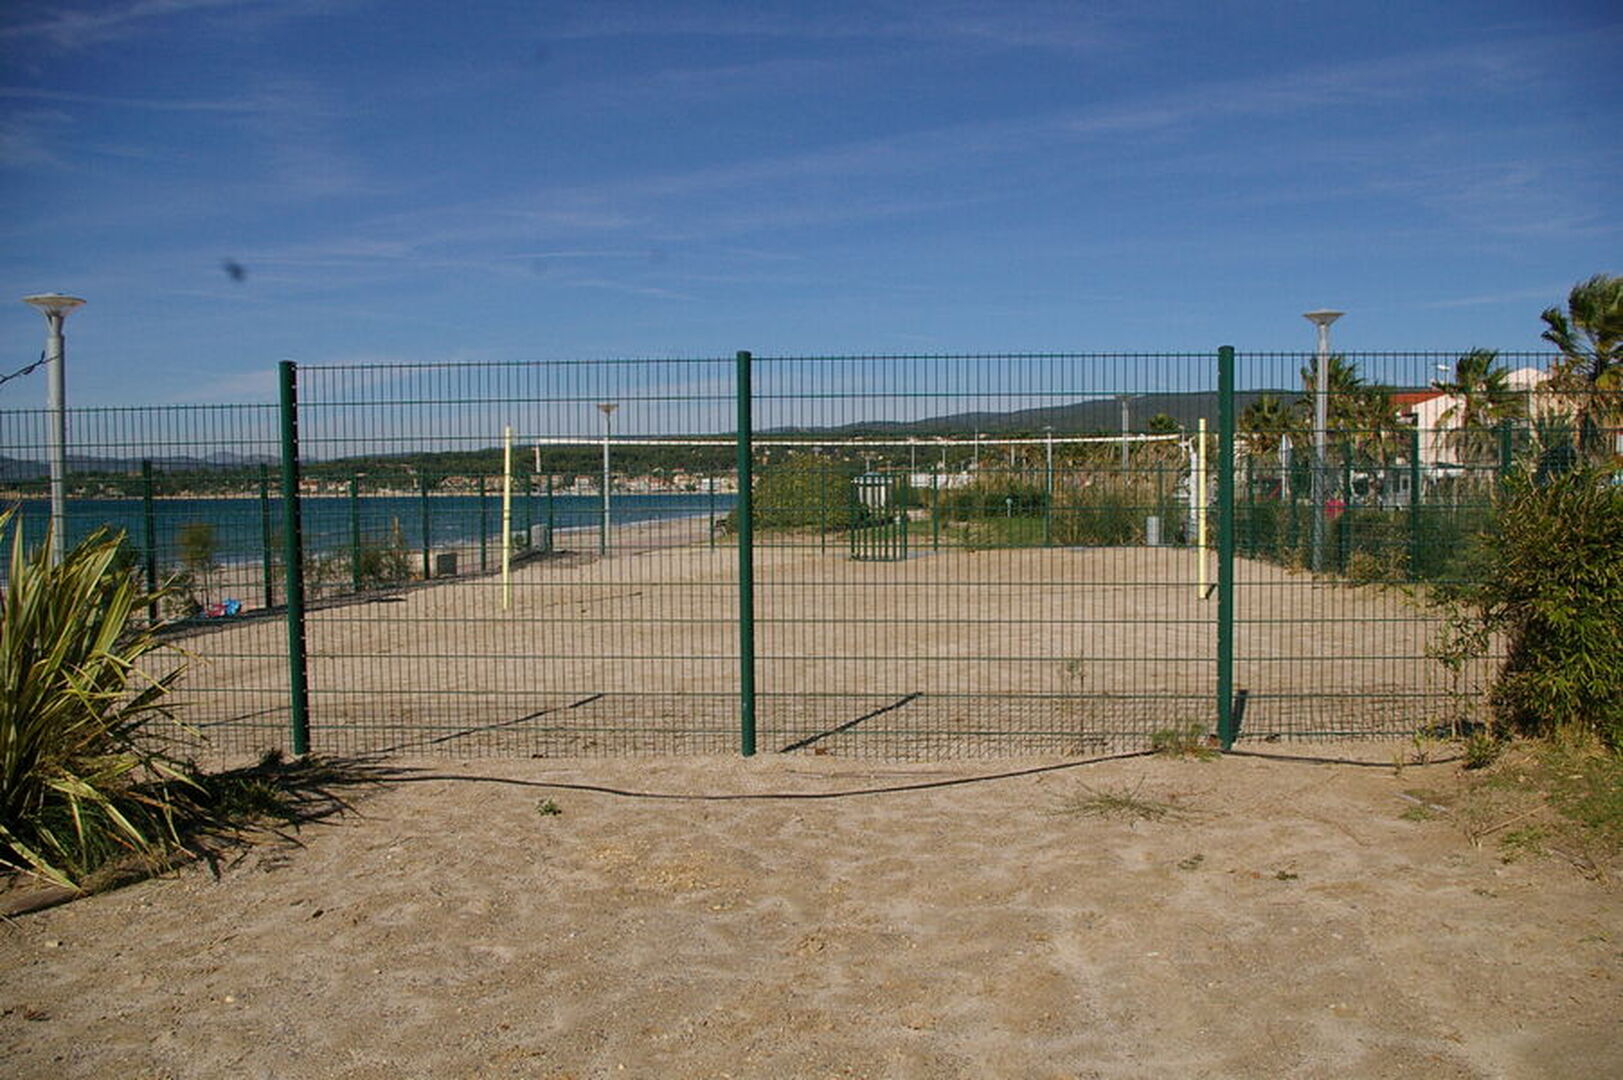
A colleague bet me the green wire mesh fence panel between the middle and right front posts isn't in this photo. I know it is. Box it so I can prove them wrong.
[755,356,1216,758]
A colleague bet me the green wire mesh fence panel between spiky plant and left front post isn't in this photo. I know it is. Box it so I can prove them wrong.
[0,404,287,757]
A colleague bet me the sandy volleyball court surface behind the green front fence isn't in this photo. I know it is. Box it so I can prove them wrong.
[154,520,1485,760]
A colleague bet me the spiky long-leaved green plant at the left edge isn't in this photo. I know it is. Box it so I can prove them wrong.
[0,512,187,883]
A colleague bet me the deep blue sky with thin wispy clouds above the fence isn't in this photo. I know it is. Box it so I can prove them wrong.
[0,0,1623,408]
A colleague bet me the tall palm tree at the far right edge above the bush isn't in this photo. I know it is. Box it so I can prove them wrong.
[1542,274,1623,455]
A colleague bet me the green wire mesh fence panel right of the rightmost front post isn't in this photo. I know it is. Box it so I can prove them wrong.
[1233,351,1568,737]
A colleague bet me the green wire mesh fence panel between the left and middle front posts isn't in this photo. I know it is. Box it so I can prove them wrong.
[299,361,737,757]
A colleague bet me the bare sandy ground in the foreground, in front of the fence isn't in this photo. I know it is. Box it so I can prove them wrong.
[0,744,1623,1080]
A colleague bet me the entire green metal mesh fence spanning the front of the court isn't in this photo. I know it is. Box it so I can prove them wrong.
[0,349,1597,758]
